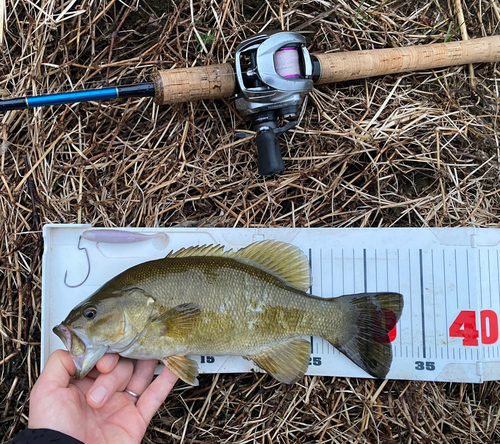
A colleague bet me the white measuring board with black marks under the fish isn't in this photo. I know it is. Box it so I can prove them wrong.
[42,225,500,382]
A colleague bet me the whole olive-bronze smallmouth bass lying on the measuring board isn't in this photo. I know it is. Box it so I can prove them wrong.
[53,241,403,384]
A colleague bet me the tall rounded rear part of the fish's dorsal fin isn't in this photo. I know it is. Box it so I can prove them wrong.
[233,240,311,291]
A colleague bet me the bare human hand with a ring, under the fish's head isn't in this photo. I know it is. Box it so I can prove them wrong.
[28,350,177,444]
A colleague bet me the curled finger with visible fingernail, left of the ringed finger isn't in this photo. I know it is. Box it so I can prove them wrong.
[87,359,134,409]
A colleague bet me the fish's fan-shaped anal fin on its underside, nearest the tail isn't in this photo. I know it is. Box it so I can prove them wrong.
[244,339,311,384]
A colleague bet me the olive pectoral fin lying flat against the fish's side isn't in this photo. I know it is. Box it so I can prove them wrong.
[153,303,201,338]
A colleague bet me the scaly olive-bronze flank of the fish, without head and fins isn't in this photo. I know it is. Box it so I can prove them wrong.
[115,257,328,359]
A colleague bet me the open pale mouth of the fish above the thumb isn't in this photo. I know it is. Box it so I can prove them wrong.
[52,324,108,379]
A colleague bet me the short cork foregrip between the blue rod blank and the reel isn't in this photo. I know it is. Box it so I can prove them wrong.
[152,63,236,105]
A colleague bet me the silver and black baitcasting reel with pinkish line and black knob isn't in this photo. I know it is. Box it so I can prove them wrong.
[235,31,314,176]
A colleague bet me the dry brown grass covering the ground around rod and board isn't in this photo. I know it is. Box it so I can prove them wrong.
[0,0,500,444]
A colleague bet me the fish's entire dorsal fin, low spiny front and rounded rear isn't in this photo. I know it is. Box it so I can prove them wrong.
[167,240,311,291]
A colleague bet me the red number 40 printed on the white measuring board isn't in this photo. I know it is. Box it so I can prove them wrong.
[450,310,498,347]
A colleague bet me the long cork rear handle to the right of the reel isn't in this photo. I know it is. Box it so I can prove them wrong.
[314,36,500,84]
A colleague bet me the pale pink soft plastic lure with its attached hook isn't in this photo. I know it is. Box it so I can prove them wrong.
[64,228,169,288]
